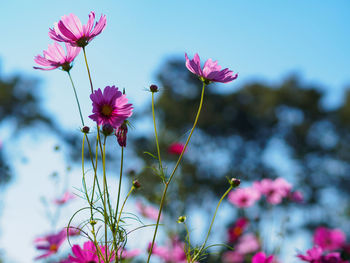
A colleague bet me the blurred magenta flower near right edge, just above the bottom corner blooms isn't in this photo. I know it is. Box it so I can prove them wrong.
[313,227,346,251]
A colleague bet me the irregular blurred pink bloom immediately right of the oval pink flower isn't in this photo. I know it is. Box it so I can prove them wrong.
[253,177,292,205]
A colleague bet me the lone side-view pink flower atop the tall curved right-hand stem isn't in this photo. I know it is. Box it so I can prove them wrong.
[185,53,238,83]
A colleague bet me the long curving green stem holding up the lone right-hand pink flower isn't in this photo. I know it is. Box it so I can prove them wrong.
[147,82,205,263]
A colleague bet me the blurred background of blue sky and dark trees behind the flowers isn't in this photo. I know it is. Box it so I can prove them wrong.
[0,0,350,263]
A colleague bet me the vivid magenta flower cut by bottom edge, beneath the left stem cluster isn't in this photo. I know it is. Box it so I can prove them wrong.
[69,241,115,263]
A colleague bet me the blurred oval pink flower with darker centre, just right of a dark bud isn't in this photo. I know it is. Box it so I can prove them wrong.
[228,187,260,208]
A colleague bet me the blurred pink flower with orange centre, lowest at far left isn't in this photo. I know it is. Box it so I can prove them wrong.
[34,229,67,259]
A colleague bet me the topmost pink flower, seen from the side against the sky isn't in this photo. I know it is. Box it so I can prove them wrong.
[49,12,107,47]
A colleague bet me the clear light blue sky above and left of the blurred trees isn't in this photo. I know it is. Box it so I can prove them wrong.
[0,0,350,263]
